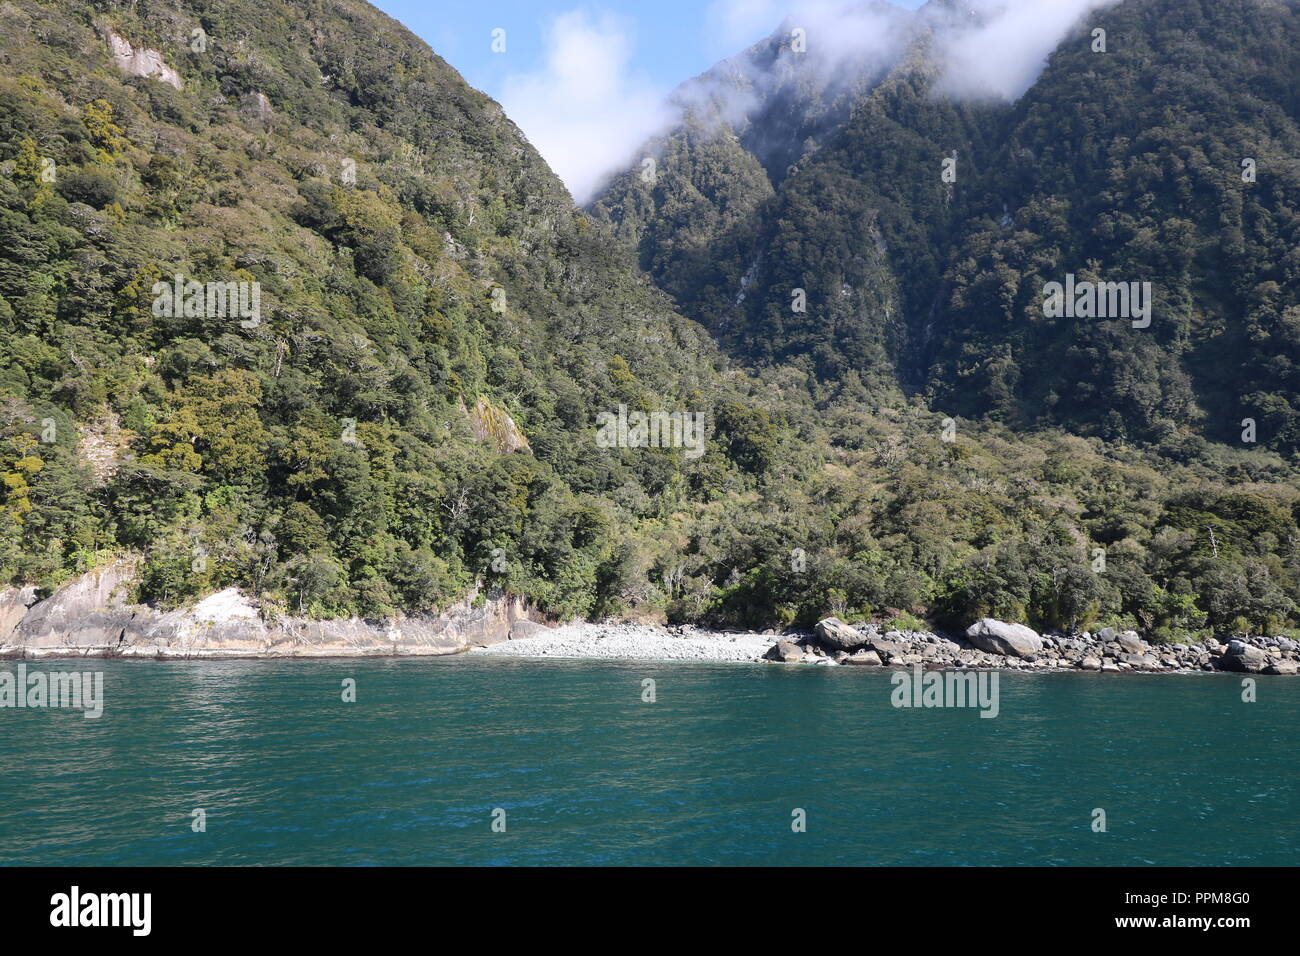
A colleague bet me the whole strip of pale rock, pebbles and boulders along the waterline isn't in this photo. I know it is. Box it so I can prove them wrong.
[0,559,1300,675]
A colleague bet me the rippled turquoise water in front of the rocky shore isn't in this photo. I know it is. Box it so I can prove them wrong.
[0,657,1300,865]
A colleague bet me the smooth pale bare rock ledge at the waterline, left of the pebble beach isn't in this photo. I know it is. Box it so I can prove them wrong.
[0,561,533,658]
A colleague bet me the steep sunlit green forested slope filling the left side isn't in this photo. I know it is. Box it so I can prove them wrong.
[0,0,780,614]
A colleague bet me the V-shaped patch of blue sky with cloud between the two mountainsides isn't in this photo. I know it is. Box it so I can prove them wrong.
[372,0,923,202]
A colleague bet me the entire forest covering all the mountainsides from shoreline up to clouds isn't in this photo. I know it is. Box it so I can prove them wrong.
[0,0,1300,639]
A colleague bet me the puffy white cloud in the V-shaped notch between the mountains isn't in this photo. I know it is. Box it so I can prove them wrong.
[501,10,671,203]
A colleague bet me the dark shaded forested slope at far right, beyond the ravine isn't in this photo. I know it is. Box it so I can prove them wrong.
[930,0,1300,454]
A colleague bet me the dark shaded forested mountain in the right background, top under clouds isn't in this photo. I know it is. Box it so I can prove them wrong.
[593,0,1300,455]
